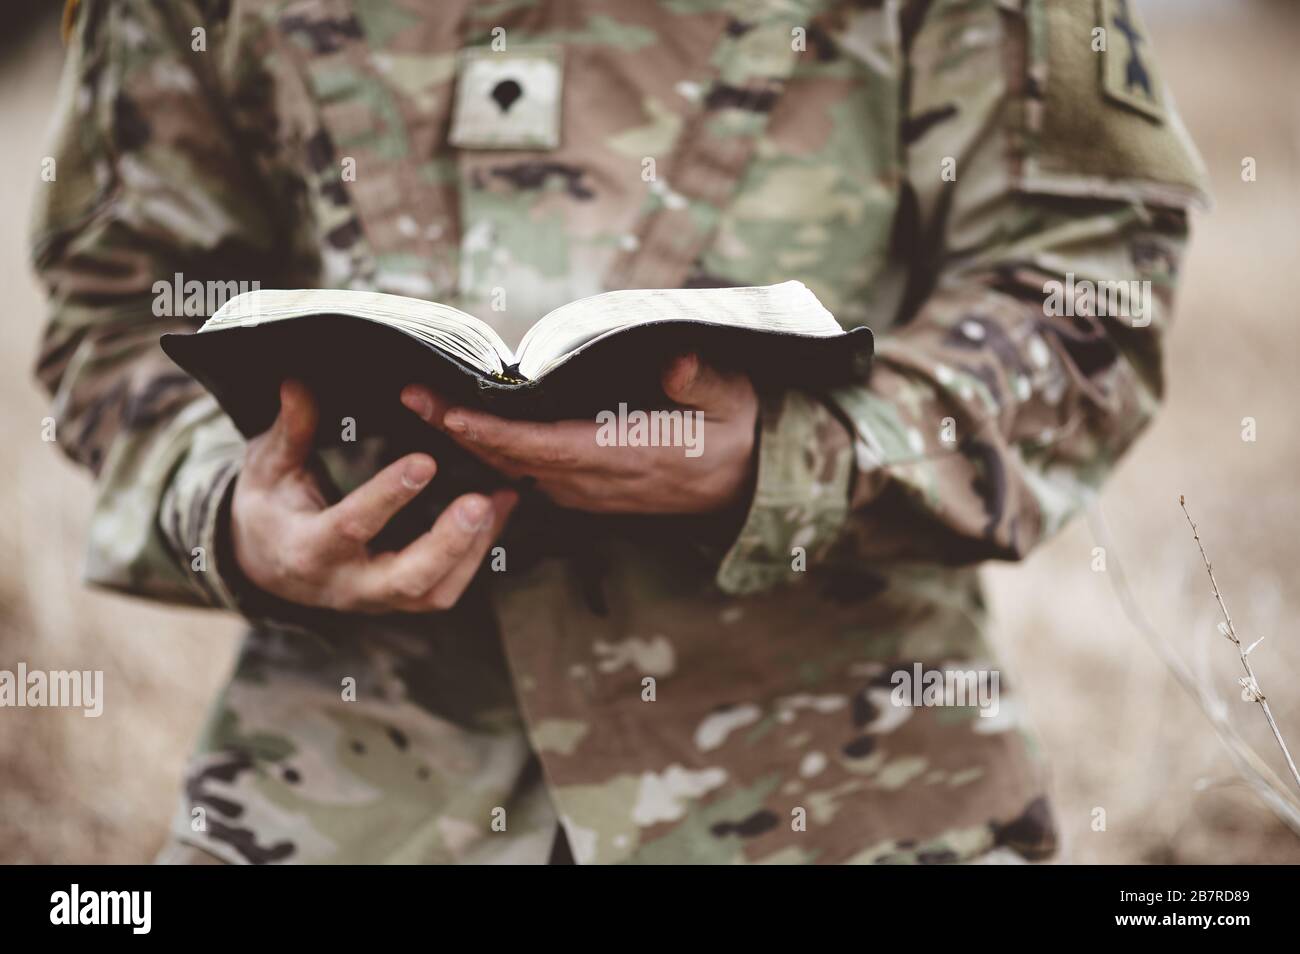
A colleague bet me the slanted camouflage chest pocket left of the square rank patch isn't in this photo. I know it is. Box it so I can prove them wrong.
[276,0,459,298]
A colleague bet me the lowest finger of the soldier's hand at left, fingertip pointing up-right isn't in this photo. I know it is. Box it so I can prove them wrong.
[338,494,493,607]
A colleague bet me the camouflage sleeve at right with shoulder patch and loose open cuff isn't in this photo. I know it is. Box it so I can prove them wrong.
[718,0,1204,593]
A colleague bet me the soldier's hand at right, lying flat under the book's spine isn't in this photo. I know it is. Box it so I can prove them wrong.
[402,355,758,513]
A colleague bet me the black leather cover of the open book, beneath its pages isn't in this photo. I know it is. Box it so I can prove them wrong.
[161,315,872,443]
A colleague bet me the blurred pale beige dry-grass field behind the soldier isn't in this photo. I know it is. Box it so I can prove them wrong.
[0,0,1300,863]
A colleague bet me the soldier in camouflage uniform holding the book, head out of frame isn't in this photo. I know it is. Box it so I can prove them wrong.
[34,0,1204,863]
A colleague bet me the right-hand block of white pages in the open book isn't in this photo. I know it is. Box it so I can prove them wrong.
[517,282,844,380]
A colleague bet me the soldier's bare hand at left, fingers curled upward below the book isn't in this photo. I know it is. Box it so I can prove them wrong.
[230,381,519,612]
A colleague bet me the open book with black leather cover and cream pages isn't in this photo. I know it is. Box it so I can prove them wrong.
[163,282,872,434]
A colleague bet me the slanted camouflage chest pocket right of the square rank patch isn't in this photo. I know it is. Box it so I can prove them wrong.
[699,3,902,326]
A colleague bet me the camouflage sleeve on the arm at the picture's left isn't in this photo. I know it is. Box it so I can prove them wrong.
[31,0,299,606]
